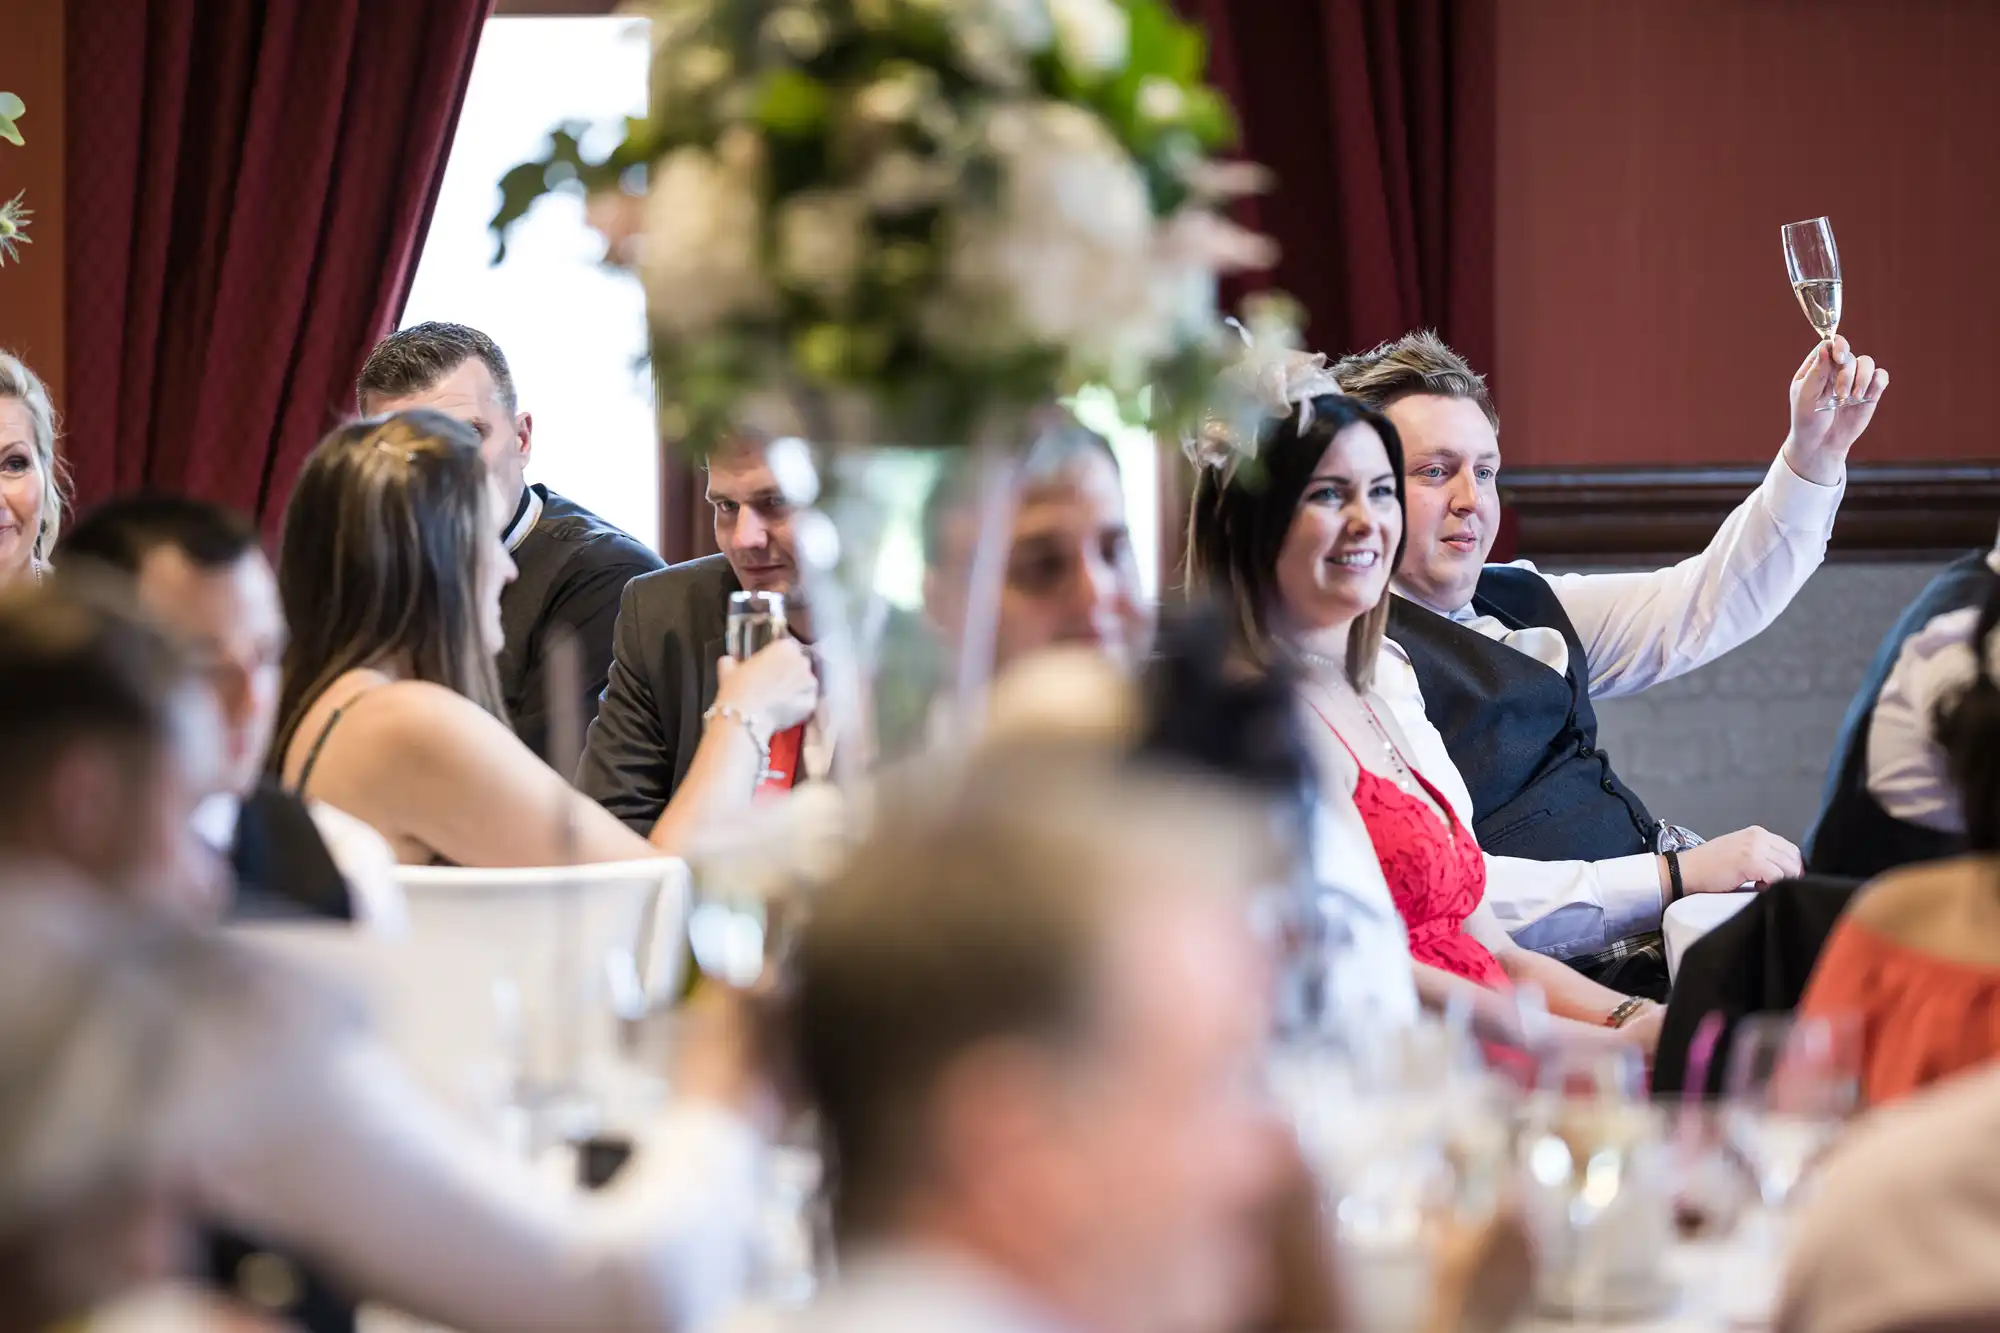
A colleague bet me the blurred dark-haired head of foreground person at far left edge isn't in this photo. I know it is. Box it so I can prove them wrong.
[0,574,222,909]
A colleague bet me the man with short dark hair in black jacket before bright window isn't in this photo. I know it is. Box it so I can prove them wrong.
[354,324,660,773]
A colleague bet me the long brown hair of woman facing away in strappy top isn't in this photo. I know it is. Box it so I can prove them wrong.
[270,408,506,773]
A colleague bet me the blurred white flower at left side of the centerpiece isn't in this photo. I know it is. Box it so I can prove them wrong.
[640,130,774,338]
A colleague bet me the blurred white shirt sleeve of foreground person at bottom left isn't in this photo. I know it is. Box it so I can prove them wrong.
[196,1037,760,1333]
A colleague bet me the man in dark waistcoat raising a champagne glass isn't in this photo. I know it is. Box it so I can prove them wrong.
[1334,332,1888,993]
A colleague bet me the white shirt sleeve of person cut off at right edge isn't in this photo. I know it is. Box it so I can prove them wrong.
[1864,606,1980,833]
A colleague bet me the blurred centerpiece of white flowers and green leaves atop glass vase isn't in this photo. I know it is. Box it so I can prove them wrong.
[494,0,1272,448]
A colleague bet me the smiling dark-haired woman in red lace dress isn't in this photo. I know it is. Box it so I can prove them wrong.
[1188,376,1664,1055]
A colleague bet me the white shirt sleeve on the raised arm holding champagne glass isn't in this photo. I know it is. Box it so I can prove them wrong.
[1518,454,1846,699]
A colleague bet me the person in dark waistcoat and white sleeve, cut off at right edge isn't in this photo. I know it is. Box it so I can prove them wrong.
[1806,520,2000,879]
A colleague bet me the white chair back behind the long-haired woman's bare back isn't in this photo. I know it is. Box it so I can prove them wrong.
[396,859,688,1089]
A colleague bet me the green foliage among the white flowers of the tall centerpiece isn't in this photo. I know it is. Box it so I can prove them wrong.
[492,0,1236,446]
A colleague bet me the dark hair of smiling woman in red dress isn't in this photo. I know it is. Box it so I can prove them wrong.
[1188,394,1408,691]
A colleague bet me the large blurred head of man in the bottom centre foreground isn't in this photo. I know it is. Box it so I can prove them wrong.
[796,745,1280,1333]
